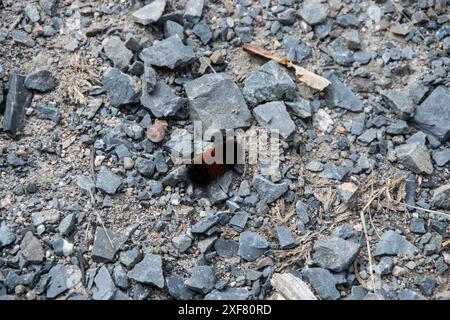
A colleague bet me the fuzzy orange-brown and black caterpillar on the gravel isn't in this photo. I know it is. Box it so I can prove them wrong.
[187,139,241,187]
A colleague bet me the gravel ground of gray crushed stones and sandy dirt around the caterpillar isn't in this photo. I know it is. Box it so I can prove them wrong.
[0,0,450,300]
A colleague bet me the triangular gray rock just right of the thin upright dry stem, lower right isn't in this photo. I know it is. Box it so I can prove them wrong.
[374,230,419,256]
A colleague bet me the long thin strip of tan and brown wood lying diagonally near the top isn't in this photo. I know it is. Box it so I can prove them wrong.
[244,44,330,91]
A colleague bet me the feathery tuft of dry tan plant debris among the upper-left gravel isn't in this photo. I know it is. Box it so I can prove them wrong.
[61,54,101,104]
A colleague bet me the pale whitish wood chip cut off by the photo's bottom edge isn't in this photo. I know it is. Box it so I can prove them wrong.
[270,273,317,300]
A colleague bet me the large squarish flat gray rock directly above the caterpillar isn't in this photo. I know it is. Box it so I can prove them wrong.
[185,73,252,130]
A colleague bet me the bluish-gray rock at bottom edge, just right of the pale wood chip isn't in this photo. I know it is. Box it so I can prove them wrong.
[303,268,341,300]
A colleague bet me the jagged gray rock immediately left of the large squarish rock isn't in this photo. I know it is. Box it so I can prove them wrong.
[141,81,186,118]
